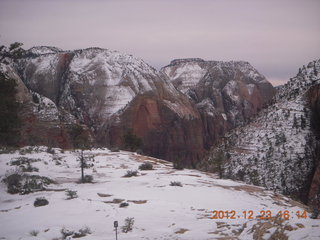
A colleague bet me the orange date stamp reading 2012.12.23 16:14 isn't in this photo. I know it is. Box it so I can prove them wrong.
[211,210,308,220]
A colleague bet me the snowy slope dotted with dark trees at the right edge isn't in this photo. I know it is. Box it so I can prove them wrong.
[203,60,320,202]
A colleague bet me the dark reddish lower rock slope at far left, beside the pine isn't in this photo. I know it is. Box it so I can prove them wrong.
[0,64,91,148]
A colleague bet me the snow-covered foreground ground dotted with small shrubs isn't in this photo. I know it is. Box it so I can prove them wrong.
[0,147,320,240]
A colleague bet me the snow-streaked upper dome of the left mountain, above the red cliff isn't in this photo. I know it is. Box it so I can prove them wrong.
[16,47,180,128]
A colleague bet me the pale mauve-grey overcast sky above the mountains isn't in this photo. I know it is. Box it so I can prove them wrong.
[0,0,320,85]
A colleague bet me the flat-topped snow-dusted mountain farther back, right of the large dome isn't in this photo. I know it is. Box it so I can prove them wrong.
[161,58,275,127]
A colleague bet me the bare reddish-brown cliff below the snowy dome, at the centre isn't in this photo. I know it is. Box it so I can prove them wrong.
[98,93,205,167]
